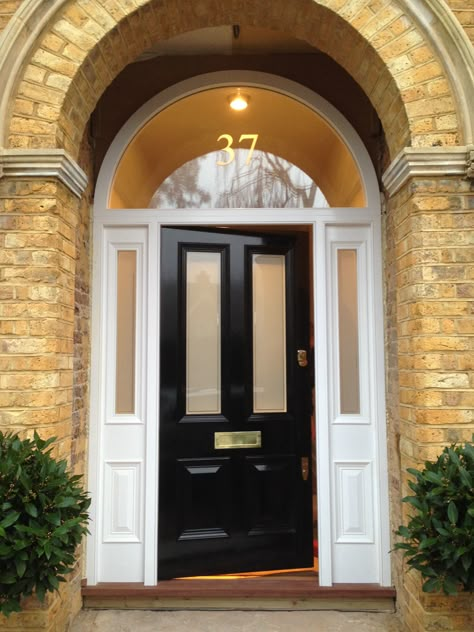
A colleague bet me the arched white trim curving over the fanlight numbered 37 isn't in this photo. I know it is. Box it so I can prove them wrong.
[94,70,380,212]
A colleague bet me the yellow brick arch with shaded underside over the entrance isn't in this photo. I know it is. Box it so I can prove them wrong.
[3,0,460,157]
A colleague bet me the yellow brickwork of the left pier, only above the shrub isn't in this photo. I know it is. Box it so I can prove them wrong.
[0,179,77,455]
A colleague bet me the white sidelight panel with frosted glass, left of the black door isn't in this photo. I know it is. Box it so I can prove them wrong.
[88,226,150,583]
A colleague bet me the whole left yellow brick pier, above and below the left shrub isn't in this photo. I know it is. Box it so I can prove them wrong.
[0,174,85,632]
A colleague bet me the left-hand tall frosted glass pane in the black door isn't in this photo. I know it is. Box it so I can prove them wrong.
[186,252,221,415]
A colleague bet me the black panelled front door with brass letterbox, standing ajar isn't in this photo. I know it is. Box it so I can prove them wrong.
[158,228,313,579]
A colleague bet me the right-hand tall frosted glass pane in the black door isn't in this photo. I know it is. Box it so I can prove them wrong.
[252,254,286,413]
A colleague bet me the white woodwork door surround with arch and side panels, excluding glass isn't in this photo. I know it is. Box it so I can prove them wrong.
[87,72,391,586]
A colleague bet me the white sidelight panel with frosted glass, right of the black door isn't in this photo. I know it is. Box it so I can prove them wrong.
[324,223,390,585]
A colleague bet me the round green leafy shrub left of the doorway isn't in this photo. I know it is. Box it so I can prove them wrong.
[0,432,90,616]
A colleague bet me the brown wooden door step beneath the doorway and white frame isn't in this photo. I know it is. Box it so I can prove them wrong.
[82,577,396,612]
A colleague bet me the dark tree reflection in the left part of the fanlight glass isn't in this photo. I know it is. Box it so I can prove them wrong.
[150,156,211,208]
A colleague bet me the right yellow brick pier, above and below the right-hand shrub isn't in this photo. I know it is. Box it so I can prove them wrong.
[385,178,474,632]
